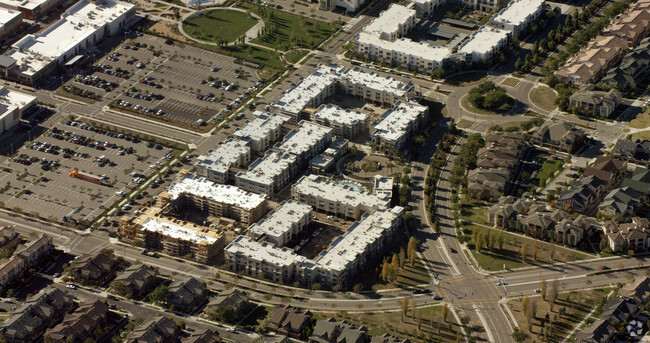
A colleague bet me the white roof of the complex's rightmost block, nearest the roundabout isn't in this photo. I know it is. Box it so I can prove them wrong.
[372,101,427,141]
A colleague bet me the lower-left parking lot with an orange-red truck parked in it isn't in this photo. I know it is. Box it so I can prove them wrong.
[0,120,172,223]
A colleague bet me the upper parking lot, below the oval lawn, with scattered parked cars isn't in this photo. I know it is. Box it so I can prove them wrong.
[60,32,265,127]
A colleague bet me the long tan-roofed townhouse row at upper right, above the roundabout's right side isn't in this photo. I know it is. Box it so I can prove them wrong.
[555,35,628,86]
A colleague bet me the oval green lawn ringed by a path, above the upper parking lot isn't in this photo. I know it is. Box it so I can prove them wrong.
[183,9,257,42]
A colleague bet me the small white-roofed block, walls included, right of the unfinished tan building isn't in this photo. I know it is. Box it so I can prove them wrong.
[248,200,312,248]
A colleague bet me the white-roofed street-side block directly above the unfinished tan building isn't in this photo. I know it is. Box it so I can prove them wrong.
[195,139,251,183]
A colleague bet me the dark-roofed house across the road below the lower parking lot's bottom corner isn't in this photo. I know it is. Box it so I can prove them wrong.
[70,253,116,285]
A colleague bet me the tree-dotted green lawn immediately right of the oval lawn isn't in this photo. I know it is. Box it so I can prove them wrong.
[241,2,337,51]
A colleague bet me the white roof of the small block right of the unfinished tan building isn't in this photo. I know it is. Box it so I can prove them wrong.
[248,200,312,241]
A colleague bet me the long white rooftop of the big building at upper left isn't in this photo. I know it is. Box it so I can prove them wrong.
[7,0,134,75]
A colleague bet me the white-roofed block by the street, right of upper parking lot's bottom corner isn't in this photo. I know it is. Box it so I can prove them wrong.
[233,111,290,154]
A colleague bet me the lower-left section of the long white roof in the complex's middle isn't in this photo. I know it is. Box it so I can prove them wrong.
[237,150,297,185]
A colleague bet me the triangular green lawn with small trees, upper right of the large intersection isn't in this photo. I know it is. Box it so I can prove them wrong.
[462,222,590,271]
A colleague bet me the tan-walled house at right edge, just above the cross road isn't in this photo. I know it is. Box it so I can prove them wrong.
[602,217,650,252]
